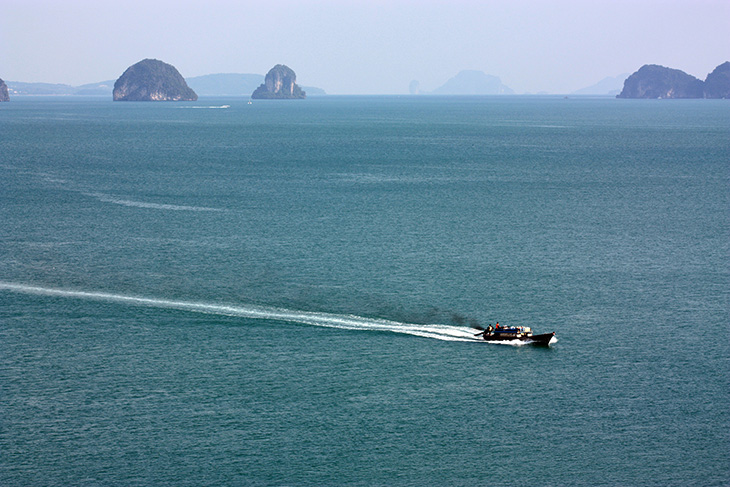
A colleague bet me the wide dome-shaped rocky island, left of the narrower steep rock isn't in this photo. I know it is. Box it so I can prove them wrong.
[112,59,198,101]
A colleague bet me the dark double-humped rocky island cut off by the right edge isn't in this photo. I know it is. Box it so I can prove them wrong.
[616,62,730,99]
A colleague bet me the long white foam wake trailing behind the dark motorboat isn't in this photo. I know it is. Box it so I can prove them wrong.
[0,281,486,343]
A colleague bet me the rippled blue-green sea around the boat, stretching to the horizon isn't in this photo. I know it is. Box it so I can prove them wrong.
[0,96,730,487]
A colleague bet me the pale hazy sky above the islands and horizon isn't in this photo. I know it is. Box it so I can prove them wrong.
[0,0,730,94]
